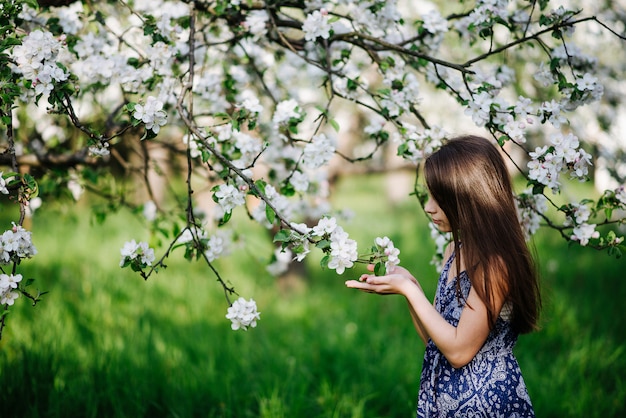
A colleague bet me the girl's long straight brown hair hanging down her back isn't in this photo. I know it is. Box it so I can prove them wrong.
[424,135,541,333]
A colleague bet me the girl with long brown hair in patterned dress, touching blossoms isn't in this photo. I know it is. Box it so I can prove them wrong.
[346,136,541,417]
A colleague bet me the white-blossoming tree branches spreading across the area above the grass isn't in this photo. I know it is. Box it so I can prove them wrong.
[0,0,626,336]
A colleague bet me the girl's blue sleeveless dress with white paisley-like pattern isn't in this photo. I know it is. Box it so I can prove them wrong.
[417,250,535,418]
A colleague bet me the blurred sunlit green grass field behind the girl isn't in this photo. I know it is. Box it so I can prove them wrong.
[0,175,626,418]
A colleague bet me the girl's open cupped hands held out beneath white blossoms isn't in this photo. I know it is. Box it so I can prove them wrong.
[346,264,422,295]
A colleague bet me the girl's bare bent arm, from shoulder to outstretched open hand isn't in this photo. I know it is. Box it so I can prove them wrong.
[346,272,502,368]
